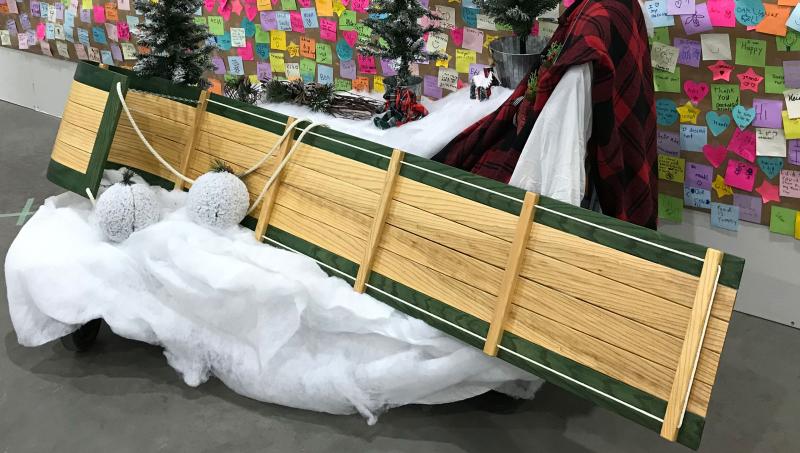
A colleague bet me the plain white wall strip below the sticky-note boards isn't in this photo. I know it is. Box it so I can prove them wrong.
[0,48,800,328]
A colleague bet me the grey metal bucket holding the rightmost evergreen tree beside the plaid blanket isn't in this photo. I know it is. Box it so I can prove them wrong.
[489,36,547,89]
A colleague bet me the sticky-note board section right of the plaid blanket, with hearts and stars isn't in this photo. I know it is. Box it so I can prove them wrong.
[645,0,800,237]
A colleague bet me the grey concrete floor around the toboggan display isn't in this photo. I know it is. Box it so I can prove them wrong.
[0,102,800,453]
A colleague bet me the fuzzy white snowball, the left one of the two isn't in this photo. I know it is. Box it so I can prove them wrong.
[95,183,160,242]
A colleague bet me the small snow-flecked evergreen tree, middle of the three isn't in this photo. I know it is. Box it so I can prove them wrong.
[358,0,447,86]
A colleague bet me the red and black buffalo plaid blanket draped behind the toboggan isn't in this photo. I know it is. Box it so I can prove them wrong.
[434,0,658,228]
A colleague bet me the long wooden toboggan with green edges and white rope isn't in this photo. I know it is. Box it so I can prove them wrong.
[48,63,744,449]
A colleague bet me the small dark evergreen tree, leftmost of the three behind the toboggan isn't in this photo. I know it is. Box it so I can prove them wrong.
[133,0,215,87]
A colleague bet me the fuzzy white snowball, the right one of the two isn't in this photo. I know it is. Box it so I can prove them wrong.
[186,171,250,228]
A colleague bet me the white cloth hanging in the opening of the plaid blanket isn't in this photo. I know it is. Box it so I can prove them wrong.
[509,63,592,205]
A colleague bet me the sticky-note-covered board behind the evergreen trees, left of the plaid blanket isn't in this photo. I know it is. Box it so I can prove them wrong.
[0,0,509,98]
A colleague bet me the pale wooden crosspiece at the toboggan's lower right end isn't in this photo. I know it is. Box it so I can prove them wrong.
[661,249,722,442]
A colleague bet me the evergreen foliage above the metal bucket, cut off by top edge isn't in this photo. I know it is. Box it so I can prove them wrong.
[475,0,560,53]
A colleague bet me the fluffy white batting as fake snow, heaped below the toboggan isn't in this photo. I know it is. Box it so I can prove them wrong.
[5,172,540,423]
